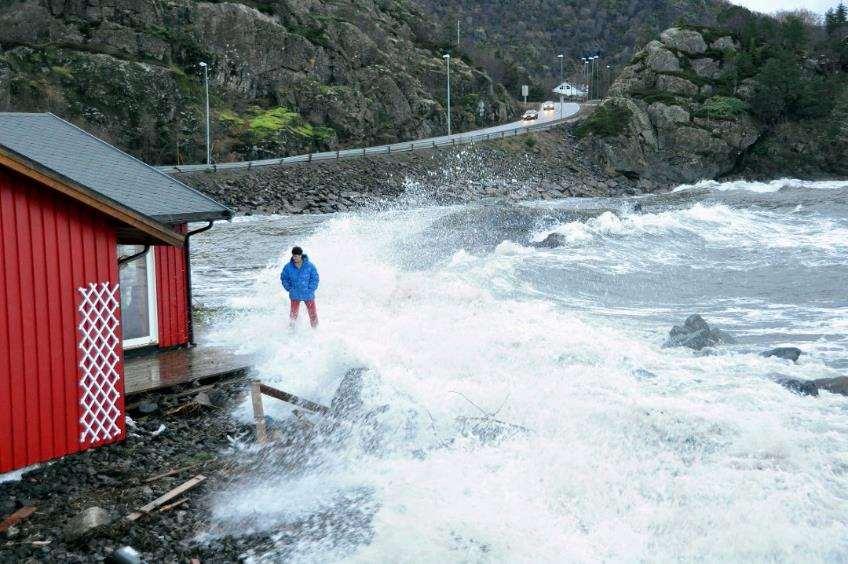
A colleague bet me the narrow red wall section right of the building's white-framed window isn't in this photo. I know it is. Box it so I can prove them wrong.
[155,225,191,348]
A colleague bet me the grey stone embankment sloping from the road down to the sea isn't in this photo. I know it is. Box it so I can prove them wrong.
[175,126,662,214]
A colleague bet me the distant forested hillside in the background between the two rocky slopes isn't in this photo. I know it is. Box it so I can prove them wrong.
[416,0,741,98]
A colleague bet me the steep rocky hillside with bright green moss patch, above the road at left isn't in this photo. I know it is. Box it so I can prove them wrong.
[0,0,517,164]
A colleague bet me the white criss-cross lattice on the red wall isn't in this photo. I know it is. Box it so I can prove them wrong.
[78,282,121,444]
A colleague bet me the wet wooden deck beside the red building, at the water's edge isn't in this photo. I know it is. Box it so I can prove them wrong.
[124,345,253,396]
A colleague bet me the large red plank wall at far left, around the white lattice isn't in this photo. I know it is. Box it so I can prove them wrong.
[0,169,126,472]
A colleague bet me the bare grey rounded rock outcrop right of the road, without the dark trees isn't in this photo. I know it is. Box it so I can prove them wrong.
[580,27,763,183]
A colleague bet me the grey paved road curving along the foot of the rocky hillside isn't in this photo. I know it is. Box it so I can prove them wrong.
[156,102,580,173]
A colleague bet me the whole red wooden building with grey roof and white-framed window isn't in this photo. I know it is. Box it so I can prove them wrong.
[0,113,232,473]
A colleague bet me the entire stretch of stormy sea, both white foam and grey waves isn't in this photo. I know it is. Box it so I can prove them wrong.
[193,180,848,562]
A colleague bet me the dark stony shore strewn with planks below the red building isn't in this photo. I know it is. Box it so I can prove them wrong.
[0,381,278,562]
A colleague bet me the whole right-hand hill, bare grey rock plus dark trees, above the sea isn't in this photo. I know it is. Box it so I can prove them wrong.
[577,11,848,184]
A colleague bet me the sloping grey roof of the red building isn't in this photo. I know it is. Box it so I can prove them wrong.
[0,112,233,224]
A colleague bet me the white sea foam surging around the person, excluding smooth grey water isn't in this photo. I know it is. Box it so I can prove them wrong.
[199,196,848,562]
